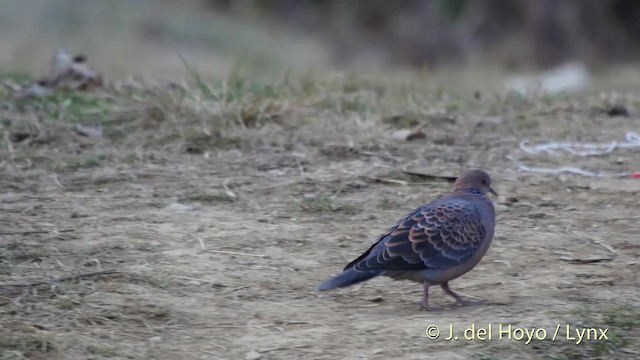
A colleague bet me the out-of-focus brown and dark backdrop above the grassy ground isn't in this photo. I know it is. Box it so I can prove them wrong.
[0,0,640,83]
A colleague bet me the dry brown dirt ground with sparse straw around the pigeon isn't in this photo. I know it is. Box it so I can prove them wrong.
[0,71,640,360]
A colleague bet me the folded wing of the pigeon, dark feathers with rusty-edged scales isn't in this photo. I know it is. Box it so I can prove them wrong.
[345,199,486,271]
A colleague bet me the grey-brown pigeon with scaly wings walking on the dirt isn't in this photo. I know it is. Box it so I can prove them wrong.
[316,169,498,311]
